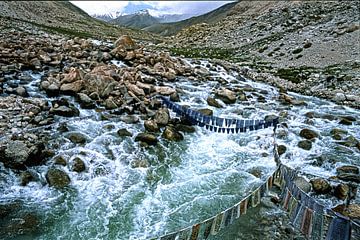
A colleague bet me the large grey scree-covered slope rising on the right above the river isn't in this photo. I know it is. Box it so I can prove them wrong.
[162,1,360,107]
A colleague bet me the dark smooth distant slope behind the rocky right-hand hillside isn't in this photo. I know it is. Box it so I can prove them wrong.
[144,2,237,36]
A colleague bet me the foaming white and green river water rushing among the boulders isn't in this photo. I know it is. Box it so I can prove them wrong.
[0,58,360,239]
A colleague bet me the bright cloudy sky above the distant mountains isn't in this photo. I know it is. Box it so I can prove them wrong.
[70,1,231,16]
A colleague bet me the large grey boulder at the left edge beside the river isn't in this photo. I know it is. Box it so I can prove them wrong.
[0,140,30,170]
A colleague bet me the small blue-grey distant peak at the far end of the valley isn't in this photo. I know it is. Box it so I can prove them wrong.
[109,10,159,29]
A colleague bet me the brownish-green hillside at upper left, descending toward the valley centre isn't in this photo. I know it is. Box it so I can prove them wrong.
[0,1,158,40]
